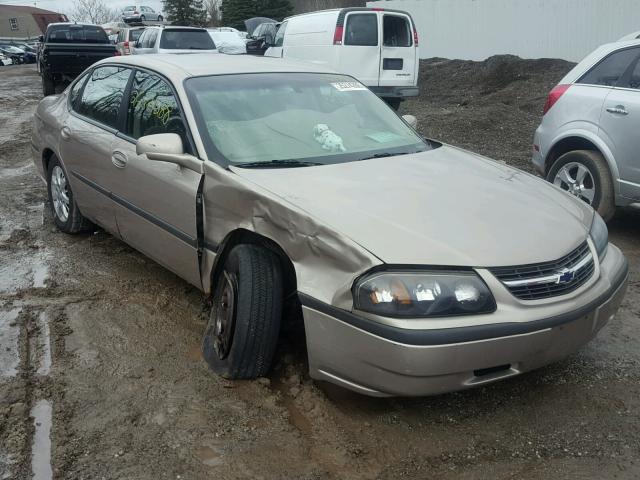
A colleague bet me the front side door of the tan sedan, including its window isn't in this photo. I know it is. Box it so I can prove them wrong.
[111,70,201,288]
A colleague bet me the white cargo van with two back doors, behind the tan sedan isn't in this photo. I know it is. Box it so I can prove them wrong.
[265,8,418,109]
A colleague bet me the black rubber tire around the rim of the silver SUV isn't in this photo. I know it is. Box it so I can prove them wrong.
[547,150,616,221]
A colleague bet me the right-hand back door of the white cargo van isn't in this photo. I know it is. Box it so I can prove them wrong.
[379,12,418,87]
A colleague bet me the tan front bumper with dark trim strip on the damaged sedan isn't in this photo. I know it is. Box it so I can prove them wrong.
[301,245,628,396]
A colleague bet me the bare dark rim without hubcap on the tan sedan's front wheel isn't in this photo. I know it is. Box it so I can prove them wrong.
[209,271,237,360]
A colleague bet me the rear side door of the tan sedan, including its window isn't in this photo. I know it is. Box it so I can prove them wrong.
[60,66,131,235]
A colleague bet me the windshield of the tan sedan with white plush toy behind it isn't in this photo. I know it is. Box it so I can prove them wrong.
[186,73,431,167]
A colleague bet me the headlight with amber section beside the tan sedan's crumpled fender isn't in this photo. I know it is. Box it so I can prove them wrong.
[354,271,496,317]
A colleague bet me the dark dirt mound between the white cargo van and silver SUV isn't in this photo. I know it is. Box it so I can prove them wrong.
[402,55,574,171]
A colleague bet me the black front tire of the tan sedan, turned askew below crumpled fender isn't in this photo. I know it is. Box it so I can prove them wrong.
[202,245,283,379]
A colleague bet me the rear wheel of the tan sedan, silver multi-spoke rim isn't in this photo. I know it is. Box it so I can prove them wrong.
[47,155,93,233]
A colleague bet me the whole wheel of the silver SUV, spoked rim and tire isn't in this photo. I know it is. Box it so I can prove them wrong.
[547,150,615,221]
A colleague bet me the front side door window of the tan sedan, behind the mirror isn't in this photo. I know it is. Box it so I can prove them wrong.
[125,70,188,144]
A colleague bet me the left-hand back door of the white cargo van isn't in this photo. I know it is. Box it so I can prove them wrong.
[336,11,380,87]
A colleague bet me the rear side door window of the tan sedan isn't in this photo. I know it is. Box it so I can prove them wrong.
[77,66,131,128]
